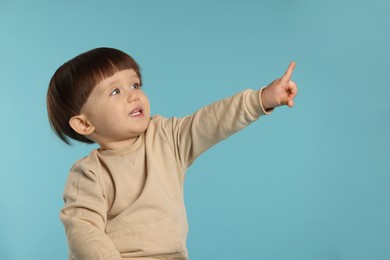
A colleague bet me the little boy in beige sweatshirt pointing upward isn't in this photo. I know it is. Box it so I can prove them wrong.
[47,48,297,260]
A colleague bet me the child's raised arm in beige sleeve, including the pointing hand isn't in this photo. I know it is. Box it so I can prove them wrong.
[161,62,297,166]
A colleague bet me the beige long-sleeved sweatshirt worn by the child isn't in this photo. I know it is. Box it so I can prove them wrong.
[60,90,266,260]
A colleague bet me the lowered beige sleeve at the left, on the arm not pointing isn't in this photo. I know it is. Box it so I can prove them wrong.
[60,164,122,260]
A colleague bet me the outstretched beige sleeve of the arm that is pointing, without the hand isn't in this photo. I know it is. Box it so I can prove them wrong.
[157,89,269,168]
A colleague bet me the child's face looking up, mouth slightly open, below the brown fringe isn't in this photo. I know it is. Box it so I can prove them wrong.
[81,69,150,149]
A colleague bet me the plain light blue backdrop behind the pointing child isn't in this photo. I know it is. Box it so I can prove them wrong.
[0,0,390,260]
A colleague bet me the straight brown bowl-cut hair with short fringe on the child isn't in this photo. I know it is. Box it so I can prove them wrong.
[46,48,142,144]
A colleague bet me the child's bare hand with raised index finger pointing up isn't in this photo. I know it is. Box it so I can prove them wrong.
[261,62,298,111]
